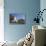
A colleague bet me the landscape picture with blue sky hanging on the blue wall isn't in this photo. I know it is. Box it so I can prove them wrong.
[9,13,25,24]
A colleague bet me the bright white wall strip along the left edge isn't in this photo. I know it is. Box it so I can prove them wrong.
[0,0,4,41]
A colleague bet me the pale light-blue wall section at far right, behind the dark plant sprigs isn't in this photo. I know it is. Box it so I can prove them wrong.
[40,0,46,43]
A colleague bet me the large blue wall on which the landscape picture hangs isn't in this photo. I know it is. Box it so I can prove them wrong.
[4,0,40,41]
